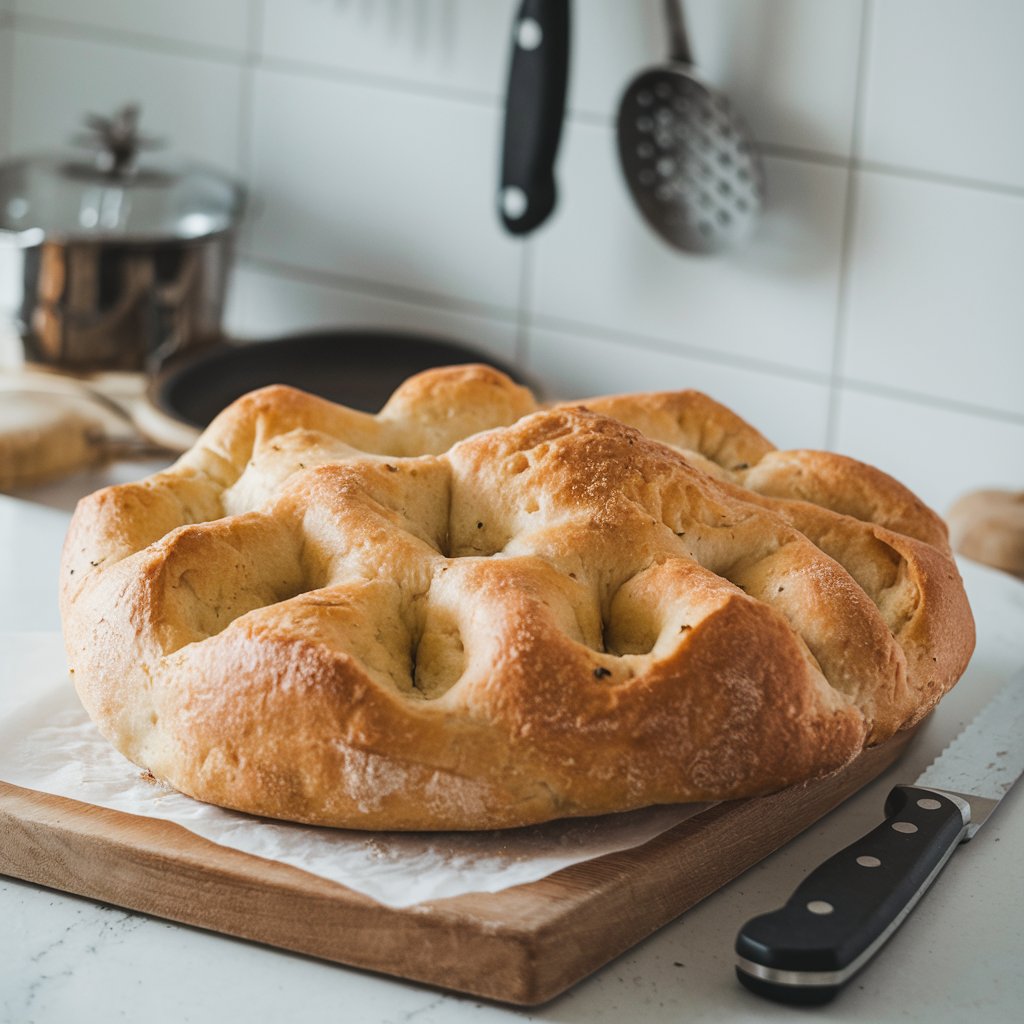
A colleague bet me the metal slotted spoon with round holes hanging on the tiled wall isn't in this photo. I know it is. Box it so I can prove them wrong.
[618,0,764,253]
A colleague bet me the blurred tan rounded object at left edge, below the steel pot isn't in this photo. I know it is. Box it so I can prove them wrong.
[0,389,104,492]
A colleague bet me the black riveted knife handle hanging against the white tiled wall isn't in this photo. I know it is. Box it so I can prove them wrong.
[498,0,569,234]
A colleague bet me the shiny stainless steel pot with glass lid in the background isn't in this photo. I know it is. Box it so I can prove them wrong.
[0,108,243,372]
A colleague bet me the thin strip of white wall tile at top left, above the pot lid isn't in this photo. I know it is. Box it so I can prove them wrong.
[15,0,251,53]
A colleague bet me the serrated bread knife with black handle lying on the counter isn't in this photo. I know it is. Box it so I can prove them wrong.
[736,672,1024,1005]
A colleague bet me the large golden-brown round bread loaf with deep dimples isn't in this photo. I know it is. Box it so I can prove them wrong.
[60,367,974,829]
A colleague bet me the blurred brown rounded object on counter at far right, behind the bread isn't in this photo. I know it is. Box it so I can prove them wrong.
[946,490,1024,580]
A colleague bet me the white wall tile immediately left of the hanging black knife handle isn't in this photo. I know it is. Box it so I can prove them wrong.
[245,71,521,307]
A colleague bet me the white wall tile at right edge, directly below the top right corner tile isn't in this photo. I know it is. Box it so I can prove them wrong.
[845,172,1024,414]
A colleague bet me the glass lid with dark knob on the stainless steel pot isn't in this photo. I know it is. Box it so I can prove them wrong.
[0,106,243,246]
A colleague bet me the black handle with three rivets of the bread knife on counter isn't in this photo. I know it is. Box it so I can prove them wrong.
[736,785,970,1004]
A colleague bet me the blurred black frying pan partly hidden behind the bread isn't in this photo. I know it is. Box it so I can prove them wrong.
[144,328,536,447]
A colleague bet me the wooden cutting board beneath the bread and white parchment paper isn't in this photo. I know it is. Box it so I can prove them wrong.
[0,733,910,1006]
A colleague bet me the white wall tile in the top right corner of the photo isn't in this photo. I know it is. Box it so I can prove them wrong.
[864,0,1024,187]
